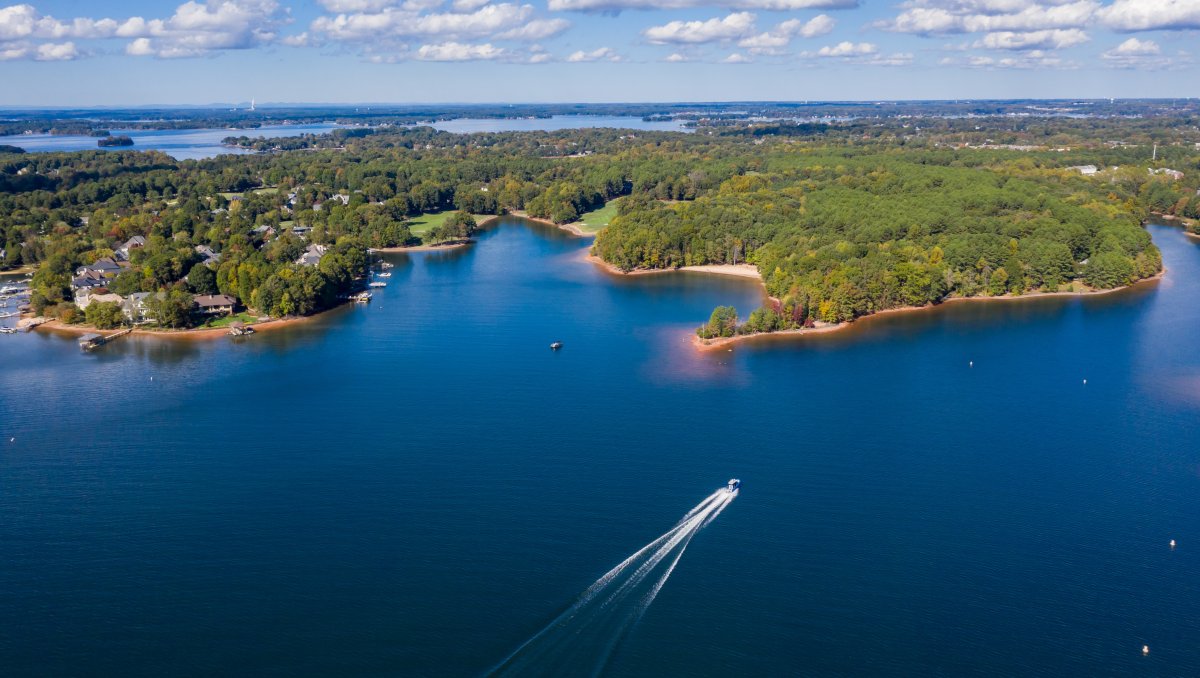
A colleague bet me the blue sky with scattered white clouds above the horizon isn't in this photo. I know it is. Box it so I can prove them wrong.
[0,0,1200,107]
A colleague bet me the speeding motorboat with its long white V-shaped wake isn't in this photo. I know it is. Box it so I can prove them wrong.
[487,486,738,676]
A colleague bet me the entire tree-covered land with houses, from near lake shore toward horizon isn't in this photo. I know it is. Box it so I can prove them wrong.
[0,102,1200,337]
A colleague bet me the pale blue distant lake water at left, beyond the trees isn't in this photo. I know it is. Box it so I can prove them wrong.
[0,122,338,160]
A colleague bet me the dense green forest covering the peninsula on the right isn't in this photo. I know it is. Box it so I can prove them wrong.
[595,149,1162,336]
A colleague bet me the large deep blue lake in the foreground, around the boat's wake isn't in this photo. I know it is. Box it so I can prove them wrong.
[0,221,1200,676]
